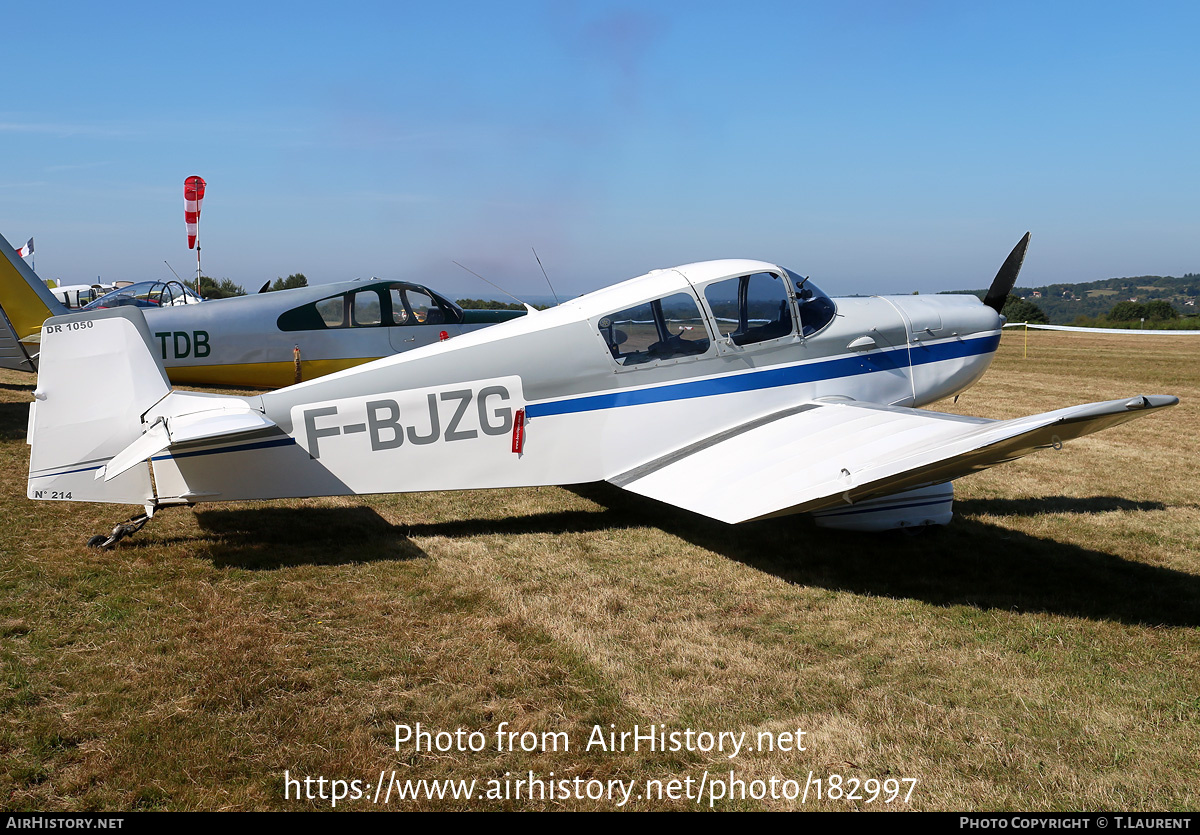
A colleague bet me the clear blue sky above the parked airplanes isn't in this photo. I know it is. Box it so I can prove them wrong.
[0,0,1200,295]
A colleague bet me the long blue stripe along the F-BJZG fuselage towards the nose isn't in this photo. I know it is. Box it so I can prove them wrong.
[526,334,1000,418]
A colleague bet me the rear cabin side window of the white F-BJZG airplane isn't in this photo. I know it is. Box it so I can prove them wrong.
[598,293,709,366]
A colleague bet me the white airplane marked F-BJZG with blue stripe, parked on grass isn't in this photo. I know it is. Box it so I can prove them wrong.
[29,235,1178,546]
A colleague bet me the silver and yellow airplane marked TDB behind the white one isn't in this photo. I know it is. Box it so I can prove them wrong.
[0,231,523,389]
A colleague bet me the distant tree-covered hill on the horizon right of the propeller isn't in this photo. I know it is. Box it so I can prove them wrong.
[948,272,1200,325]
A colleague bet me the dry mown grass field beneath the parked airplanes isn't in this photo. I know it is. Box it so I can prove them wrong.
[0,331,1200,810]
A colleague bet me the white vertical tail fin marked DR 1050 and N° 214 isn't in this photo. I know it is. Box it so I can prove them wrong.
[28,307,170,505]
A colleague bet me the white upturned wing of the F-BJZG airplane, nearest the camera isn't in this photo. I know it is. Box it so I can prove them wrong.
[608,395,1178,523]
